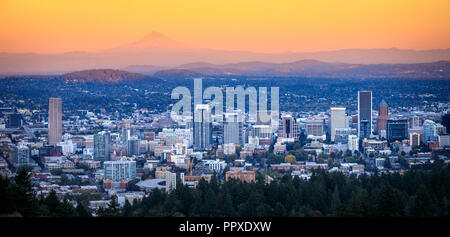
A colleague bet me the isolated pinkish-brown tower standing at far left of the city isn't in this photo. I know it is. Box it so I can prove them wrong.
[48,98,62,145]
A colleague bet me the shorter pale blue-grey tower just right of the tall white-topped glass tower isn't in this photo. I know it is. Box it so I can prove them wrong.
[223,113,245,145]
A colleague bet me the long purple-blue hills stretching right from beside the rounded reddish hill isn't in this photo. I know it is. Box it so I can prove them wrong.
[135,60,450,79]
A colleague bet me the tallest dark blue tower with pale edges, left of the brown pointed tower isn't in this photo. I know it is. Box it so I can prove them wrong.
[358,91,372,139]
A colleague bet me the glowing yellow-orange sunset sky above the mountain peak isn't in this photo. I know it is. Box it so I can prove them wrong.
[0,0,450,53]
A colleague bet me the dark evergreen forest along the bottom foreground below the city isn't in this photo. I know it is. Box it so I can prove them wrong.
[0,161,450,217]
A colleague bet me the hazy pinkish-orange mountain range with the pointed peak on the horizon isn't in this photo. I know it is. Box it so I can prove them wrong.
[0,32,450,75]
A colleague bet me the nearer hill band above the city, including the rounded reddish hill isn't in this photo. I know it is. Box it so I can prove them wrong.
[53,60,450,83]
